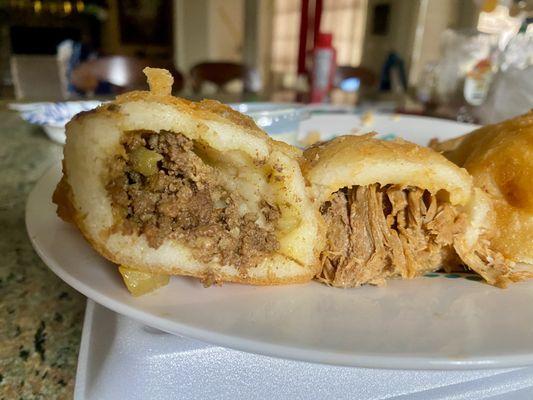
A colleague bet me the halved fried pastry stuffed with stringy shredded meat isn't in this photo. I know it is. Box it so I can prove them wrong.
[304,135,507,287]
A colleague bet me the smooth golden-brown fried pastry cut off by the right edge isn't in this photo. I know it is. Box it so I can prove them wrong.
[439,110,533,264]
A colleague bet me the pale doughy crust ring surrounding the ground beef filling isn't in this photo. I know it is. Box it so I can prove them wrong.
[53,69,322,285]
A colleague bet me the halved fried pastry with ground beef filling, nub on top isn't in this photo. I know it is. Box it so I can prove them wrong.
[54,68,320,284]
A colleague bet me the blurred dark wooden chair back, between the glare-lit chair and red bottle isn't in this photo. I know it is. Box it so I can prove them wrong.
[190,62,249,93]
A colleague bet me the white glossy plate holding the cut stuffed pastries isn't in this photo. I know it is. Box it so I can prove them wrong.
[26,116,533,369]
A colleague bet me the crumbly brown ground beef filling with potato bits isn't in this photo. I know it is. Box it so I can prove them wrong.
[106,131,280,268]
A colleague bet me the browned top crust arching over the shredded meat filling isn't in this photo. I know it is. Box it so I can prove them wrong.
[303,134,472,204]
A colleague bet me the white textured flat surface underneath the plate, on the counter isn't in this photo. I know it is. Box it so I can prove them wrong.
[74,300,533,400]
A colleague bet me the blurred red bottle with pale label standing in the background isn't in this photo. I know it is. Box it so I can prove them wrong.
[311,33,337,103]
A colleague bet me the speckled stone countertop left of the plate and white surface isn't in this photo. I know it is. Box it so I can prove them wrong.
[0,103,85,400]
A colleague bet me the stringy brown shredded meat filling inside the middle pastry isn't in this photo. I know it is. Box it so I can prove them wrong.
[319,184,461,287]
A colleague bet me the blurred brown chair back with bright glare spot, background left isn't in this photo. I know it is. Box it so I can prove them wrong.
[71,56,184,93]
